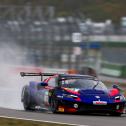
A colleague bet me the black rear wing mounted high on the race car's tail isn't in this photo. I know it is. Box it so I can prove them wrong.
[20,72,57,81]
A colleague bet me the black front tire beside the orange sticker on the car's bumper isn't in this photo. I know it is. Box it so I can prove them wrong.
[50,97,59,113]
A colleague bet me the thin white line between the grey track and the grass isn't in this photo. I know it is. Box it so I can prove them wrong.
[0,116,89,126]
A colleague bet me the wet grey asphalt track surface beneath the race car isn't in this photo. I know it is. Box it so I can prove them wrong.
[0,108,126,126]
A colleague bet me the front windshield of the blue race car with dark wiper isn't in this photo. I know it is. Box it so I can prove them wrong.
[62,79,107,91]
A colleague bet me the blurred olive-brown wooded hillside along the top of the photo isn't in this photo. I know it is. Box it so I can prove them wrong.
[0,0,126,22]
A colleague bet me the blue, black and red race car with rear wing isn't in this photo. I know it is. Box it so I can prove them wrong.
[20,72,126,116]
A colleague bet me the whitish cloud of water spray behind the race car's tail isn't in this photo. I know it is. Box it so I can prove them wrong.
[0,43,38,109]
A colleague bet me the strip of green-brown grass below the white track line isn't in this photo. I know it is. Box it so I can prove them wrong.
[0,117,68,126]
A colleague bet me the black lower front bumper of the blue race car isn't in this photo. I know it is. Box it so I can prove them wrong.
[59,100,125,113]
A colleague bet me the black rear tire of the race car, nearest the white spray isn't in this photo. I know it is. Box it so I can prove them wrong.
[22,86,32,111]
